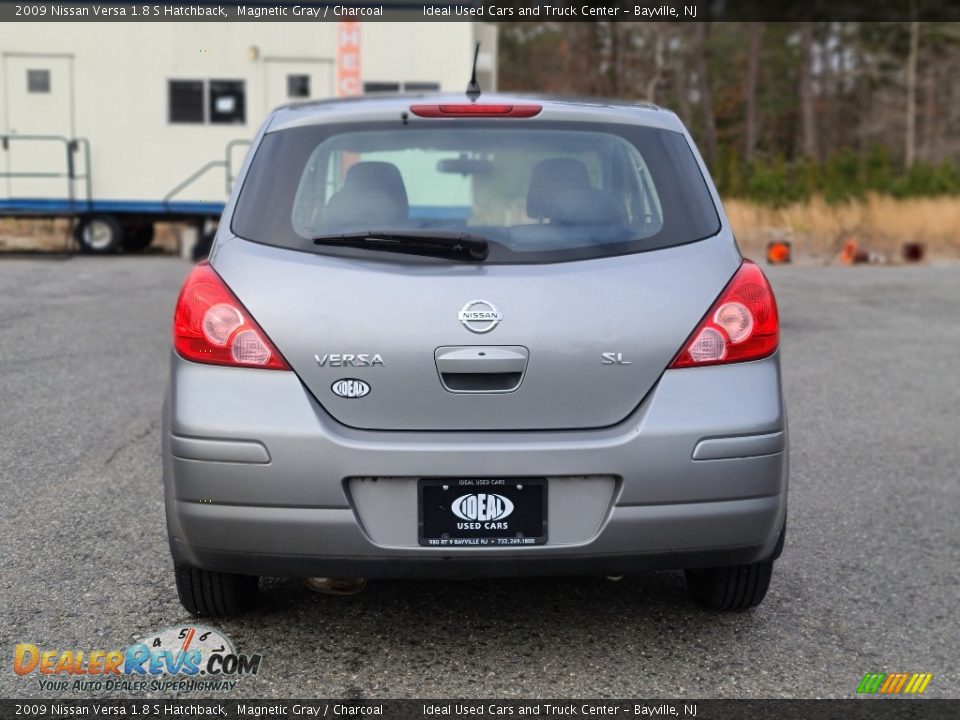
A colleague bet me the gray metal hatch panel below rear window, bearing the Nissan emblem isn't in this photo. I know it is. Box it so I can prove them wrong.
[214,232,740,431]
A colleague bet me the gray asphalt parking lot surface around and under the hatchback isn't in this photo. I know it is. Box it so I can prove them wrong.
[0,257,960,698]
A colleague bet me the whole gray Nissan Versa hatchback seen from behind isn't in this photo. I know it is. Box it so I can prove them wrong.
[163,97,787,615]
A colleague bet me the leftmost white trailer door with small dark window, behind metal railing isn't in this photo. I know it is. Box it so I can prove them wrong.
[0,53,75,202]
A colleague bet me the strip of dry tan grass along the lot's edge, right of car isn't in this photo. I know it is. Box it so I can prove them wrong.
[724,195,960,260]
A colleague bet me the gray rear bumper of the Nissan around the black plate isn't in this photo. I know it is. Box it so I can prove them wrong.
[163,355,787,577]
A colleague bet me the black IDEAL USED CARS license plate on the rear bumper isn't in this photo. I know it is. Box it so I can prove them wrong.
[418,478,547,547]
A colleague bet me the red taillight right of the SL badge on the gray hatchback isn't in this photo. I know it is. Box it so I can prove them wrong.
[670,260,780,368]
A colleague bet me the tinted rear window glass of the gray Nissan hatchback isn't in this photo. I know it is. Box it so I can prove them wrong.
[231,120,720,263]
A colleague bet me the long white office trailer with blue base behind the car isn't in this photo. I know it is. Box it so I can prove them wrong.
[0,22,496,252]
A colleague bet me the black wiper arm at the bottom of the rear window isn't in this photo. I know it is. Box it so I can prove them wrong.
[313,230,490,262]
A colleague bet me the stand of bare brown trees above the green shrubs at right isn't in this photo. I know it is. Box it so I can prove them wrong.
[500,19,960,176]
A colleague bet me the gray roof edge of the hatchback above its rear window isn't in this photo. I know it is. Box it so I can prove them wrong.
[266,93,683,132]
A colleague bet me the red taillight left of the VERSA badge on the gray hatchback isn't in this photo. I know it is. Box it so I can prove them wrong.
[173,263,290,370]
